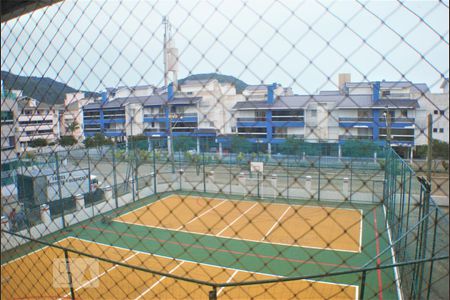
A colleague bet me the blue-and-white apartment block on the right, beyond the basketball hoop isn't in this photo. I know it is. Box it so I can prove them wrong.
[233,74,430,152]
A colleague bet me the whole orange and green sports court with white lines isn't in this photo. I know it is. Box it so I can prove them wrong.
[2,194,397,299]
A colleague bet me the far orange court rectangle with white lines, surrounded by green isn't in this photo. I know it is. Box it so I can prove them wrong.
[114,195,362,252]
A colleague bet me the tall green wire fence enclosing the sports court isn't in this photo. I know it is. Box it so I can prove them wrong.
[1,141,449,299]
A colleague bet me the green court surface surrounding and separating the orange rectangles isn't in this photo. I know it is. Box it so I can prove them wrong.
[2,193,397,299]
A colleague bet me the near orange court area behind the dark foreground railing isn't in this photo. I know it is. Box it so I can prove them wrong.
[1,237,358,299]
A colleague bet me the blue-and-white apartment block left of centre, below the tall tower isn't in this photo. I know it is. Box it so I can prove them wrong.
[83,80,236,147]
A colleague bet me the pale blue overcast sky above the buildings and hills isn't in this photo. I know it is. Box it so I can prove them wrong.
[1,0,449,94]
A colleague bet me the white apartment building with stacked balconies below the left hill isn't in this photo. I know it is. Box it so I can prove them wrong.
[17,96,63,150]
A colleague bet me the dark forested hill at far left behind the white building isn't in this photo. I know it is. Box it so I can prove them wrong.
[1,71,99,105]
